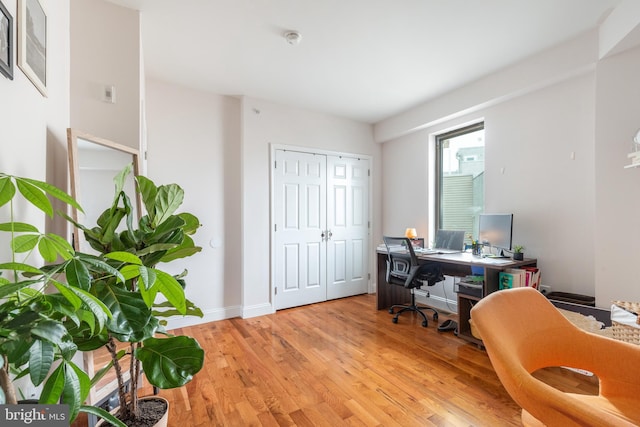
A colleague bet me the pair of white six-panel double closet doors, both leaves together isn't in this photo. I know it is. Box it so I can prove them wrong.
[272,150,369,310]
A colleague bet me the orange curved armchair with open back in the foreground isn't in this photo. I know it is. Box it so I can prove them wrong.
[471,288,640,427]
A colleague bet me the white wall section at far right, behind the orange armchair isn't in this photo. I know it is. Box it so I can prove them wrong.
[587,48,640,305]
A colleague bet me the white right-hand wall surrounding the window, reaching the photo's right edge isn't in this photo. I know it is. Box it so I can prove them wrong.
[376,29,640,307]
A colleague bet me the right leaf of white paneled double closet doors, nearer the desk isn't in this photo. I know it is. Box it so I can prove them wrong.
[327,156,369,299]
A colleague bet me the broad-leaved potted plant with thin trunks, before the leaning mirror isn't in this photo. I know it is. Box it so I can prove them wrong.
[67,167,204,425]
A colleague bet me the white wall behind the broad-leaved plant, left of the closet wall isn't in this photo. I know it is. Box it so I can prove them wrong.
[146,80,242,327]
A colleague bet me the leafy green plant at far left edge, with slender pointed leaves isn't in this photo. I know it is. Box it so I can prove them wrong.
[0,173,129,422]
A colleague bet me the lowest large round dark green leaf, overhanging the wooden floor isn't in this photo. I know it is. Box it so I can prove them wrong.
[135,336,204,389]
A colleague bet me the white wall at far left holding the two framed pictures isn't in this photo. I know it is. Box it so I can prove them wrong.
[0,0,69,241]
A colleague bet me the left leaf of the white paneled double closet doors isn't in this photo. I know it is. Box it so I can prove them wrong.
[273,150,327,310]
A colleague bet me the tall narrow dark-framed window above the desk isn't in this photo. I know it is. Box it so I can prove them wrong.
[435,123,484,242]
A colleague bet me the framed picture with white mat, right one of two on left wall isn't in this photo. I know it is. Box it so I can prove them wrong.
[18,0,47,96]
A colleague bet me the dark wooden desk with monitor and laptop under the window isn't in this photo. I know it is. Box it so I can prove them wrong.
[376,250,538,346]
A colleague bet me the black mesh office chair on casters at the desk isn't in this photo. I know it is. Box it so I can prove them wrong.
[383,236,444,327]
